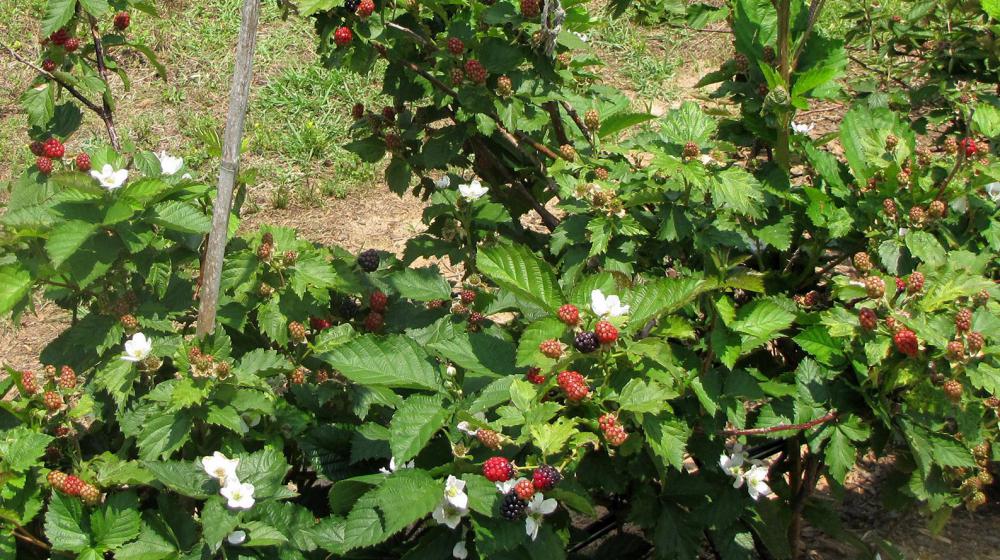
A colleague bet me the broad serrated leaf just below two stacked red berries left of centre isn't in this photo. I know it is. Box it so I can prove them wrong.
[319,335,441,390]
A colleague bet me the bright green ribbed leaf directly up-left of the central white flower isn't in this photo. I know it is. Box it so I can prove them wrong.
[477,243,563,312]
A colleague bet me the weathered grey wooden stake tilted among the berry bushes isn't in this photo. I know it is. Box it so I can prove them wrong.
[196,0,260,338]
